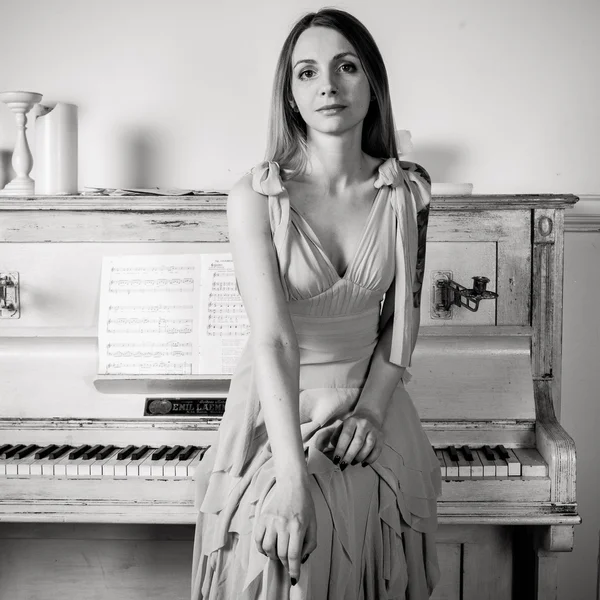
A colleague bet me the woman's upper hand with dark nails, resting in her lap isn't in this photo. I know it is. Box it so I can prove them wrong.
[331,409,384,471]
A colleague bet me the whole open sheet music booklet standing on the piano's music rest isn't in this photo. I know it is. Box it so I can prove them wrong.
[98,254,250,375]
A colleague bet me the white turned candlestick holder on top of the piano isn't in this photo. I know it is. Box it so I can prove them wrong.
[0,92,42,196]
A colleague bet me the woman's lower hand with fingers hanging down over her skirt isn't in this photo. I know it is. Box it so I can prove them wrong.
[254,480,317,585]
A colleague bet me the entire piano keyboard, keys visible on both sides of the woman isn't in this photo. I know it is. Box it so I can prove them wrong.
[0,444,548,479]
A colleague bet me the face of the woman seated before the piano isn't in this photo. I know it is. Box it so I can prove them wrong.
[292,27,371,134]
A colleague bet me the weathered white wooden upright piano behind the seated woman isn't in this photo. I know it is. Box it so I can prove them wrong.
[0,195,580,600]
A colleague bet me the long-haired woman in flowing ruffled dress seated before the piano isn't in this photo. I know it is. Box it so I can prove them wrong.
[192,9,440,600]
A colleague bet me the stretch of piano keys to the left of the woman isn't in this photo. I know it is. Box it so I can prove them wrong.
[0,444,208,479]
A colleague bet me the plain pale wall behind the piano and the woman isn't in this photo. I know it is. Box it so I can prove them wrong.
[0,0,600,600]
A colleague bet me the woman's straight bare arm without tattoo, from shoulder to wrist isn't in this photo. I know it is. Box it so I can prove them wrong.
[227,175,308,483]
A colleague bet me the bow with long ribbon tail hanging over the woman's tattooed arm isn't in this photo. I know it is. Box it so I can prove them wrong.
[374,158,431,368]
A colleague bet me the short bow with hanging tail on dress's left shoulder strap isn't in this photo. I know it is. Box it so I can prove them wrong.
[250,161,290,250]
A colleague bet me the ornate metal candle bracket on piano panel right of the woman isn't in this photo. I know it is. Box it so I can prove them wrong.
[431,271,498,319]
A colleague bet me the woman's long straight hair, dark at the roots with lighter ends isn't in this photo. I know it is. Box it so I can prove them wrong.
[265,8,398,179]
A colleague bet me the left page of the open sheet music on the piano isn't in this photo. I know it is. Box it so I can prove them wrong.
[98,255,200,375]
